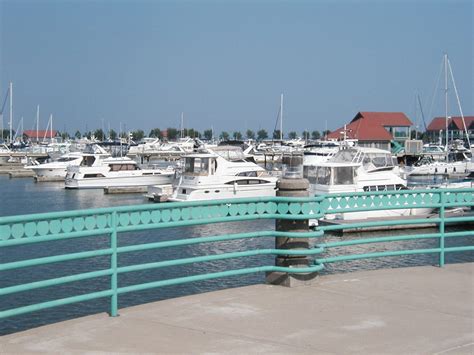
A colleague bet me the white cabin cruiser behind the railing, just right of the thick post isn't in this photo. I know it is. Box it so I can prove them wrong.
[303,147,432,220]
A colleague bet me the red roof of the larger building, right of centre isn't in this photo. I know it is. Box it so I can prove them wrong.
[328,112,412,141]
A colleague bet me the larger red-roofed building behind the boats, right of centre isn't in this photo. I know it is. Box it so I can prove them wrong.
[327,112,413,150]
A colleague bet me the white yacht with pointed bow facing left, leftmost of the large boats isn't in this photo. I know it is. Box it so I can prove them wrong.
[28,144,110,179]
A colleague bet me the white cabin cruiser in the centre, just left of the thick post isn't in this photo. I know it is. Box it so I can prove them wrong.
[146,148,277,201]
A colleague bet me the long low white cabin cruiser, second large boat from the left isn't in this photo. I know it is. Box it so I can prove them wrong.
[66,157,174,189]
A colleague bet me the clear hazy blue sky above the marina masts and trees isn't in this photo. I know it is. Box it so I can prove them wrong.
[0,0,474,134]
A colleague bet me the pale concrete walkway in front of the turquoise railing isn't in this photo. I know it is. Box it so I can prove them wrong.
[0,263,474,354]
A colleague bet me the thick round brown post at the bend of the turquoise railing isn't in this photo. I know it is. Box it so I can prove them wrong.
[266,154,317,287]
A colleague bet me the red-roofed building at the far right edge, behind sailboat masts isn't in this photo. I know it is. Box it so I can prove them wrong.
[426,116,474,143]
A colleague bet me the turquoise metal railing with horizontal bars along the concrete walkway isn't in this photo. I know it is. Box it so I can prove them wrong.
[0,188,474,319]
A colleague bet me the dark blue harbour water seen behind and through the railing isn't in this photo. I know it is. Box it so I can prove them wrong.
[0,175,474,335]
